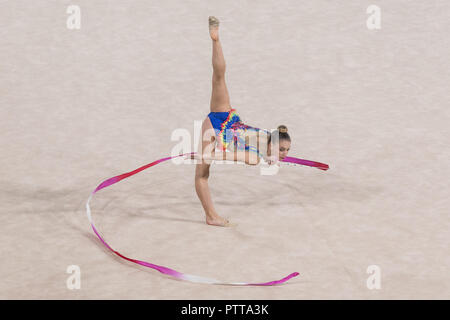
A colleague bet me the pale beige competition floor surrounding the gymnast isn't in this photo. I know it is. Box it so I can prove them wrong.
[0,0,450,299]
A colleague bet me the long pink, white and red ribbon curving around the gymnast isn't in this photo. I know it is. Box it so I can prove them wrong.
[86,152,328,286]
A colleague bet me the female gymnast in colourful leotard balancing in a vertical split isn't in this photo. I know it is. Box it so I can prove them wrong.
[191,16,291,227]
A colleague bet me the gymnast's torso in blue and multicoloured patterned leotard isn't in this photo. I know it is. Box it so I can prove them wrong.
[208,109,270,157]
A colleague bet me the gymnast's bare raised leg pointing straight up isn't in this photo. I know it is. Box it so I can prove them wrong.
[209,16,231,112]
